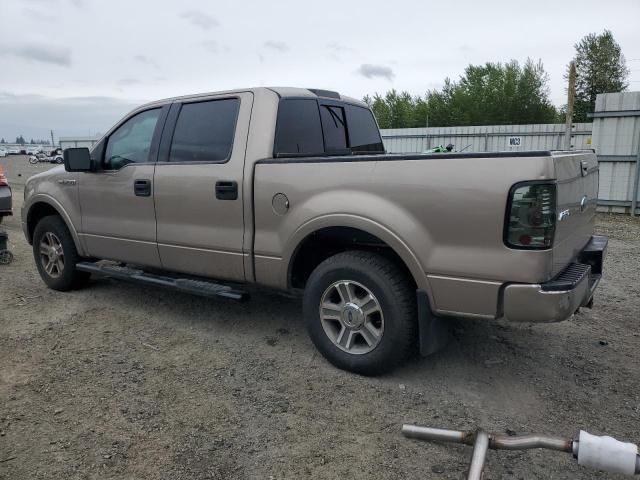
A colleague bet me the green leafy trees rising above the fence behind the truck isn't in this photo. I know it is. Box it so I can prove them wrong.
[364,30,629,128]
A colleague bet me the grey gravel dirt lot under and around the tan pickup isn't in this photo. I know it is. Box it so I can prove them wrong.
[0,157,640,480]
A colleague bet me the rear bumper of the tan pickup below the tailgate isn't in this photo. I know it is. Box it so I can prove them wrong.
[503,235,608,323]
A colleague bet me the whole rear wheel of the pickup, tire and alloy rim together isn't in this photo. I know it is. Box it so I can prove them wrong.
[304,251,417,375]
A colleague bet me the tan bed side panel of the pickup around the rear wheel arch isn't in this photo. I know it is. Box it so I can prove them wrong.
[254,156,554,316]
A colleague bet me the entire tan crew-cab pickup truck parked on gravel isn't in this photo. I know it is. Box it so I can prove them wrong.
[22,88,607,374]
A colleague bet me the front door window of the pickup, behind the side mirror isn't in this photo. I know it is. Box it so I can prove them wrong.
[103,108,160,170]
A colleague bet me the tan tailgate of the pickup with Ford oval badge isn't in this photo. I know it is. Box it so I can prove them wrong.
[553,151,598,276]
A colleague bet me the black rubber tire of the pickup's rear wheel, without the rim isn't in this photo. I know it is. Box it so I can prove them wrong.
[303,251,418,375]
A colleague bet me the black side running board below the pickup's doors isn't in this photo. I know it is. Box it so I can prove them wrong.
[76,262,249,301]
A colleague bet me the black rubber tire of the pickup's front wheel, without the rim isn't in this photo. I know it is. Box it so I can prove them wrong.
[33,215,91,292]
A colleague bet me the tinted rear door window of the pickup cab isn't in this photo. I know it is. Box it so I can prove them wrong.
[169,98,240,162]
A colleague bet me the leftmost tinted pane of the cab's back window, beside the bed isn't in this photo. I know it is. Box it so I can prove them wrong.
[275,99,324,155]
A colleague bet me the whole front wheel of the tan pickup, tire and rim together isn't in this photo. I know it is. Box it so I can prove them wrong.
[33,215,90,291]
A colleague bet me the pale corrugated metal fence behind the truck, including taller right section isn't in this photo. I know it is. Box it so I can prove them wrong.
[381,103,640,213]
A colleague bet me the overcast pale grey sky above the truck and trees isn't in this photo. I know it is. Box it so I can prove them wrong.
[0,0,640,138]
